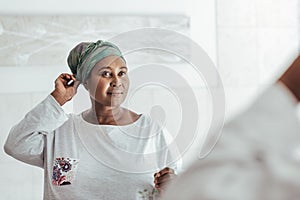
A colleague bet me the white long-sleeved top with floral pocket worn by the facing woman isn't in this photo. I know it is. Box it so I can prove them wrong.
[4,95,180,200]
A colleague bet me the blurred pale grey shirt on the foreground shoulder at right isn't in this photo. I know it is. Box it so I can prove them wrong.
[164,83,300,200]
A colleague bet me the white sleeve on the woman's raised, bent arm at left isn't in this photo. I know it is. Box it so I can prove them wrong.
[4,95,68,167]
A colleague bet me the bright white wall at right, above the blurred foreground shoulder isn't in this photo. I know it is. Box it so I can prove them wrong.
[217,0,300,118]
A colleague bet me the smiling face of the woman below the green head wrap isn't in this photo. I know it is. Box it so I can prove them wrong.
[84,56,129,107]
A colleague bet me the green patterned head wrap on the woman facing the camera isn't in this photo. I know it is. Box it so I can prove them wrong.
[68,40,126,83]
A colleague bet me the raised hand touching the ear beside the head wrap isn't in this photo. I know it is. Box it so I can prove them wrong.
[51,73,80,106]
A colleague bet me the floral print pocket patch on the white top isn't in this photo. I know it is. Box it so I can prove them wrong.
[52,157,79,186]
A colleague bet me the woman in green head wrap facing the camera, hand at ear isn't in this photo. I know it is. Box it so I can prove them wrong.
[4,41,180,200]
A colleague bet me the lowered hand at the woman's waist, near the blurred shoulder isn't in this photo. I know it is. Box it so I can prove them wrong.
[154,167,177,192]
